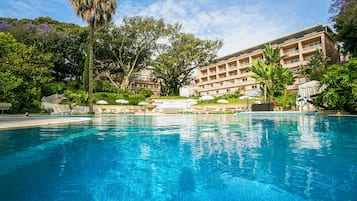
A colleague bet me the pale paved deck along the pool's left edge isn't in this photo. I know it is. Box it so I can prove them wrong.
[0,115,91,130]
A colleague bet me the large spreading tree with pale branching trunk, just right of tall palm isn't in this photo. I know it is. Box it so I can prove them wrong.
[96,17,168,91]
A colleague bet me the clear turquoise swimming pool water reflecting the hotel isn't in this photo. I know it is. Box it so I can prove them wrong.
[0,115,357,201]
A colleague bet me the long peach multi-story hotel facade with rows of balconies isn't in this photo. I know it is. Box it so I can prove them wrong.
[196,25,339,96]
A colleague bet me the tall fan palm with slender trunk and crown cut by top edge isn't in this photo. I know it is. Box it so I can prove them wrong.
[70,0,117,113]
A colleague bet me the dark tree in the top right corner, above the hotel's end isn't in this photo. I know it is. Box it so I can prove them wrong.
[330,0,357,56]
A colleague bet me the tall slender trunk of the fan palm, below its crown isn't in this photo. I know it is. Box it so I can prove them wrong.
[88,23,94,114]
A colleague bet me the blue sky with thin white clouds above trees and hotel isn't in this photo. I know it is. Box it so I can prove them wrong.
[0,0,332,56]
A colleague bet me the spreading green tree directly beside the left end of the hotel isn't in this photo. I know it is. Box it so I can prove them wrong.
[153,31,222,96]
